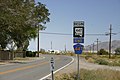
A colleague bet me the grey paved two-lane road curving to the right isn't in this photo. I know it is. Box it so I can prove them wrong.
[0,55,72,80]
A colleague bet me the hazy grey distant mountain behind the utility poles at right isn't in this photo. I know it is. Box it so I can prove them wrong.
[85,40,120,52]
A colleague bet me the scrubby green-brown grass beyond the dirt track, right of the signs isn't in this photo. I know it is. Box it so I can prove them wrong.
[85,55,120,66]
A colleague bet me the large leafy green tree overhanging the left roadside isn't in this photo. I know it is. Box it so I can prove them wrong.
[0,0,50,50]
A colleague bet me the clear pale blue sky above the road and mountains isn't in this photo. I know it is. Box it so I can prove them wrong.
[29,0,120,51]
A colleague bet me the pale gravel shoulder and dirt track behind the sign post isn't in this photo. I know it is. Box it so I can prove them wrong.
[56,57,120,75]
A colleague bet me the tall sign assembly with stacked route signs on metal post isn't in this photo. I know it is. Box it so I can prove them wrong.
[73,21,84,80]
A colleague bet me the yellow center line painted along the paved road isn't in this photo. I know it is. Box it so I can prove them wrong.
[0,59,58,75]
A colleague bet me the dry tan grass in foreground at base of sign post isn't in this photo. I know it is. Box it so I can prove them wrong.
[55,69,120,80]
